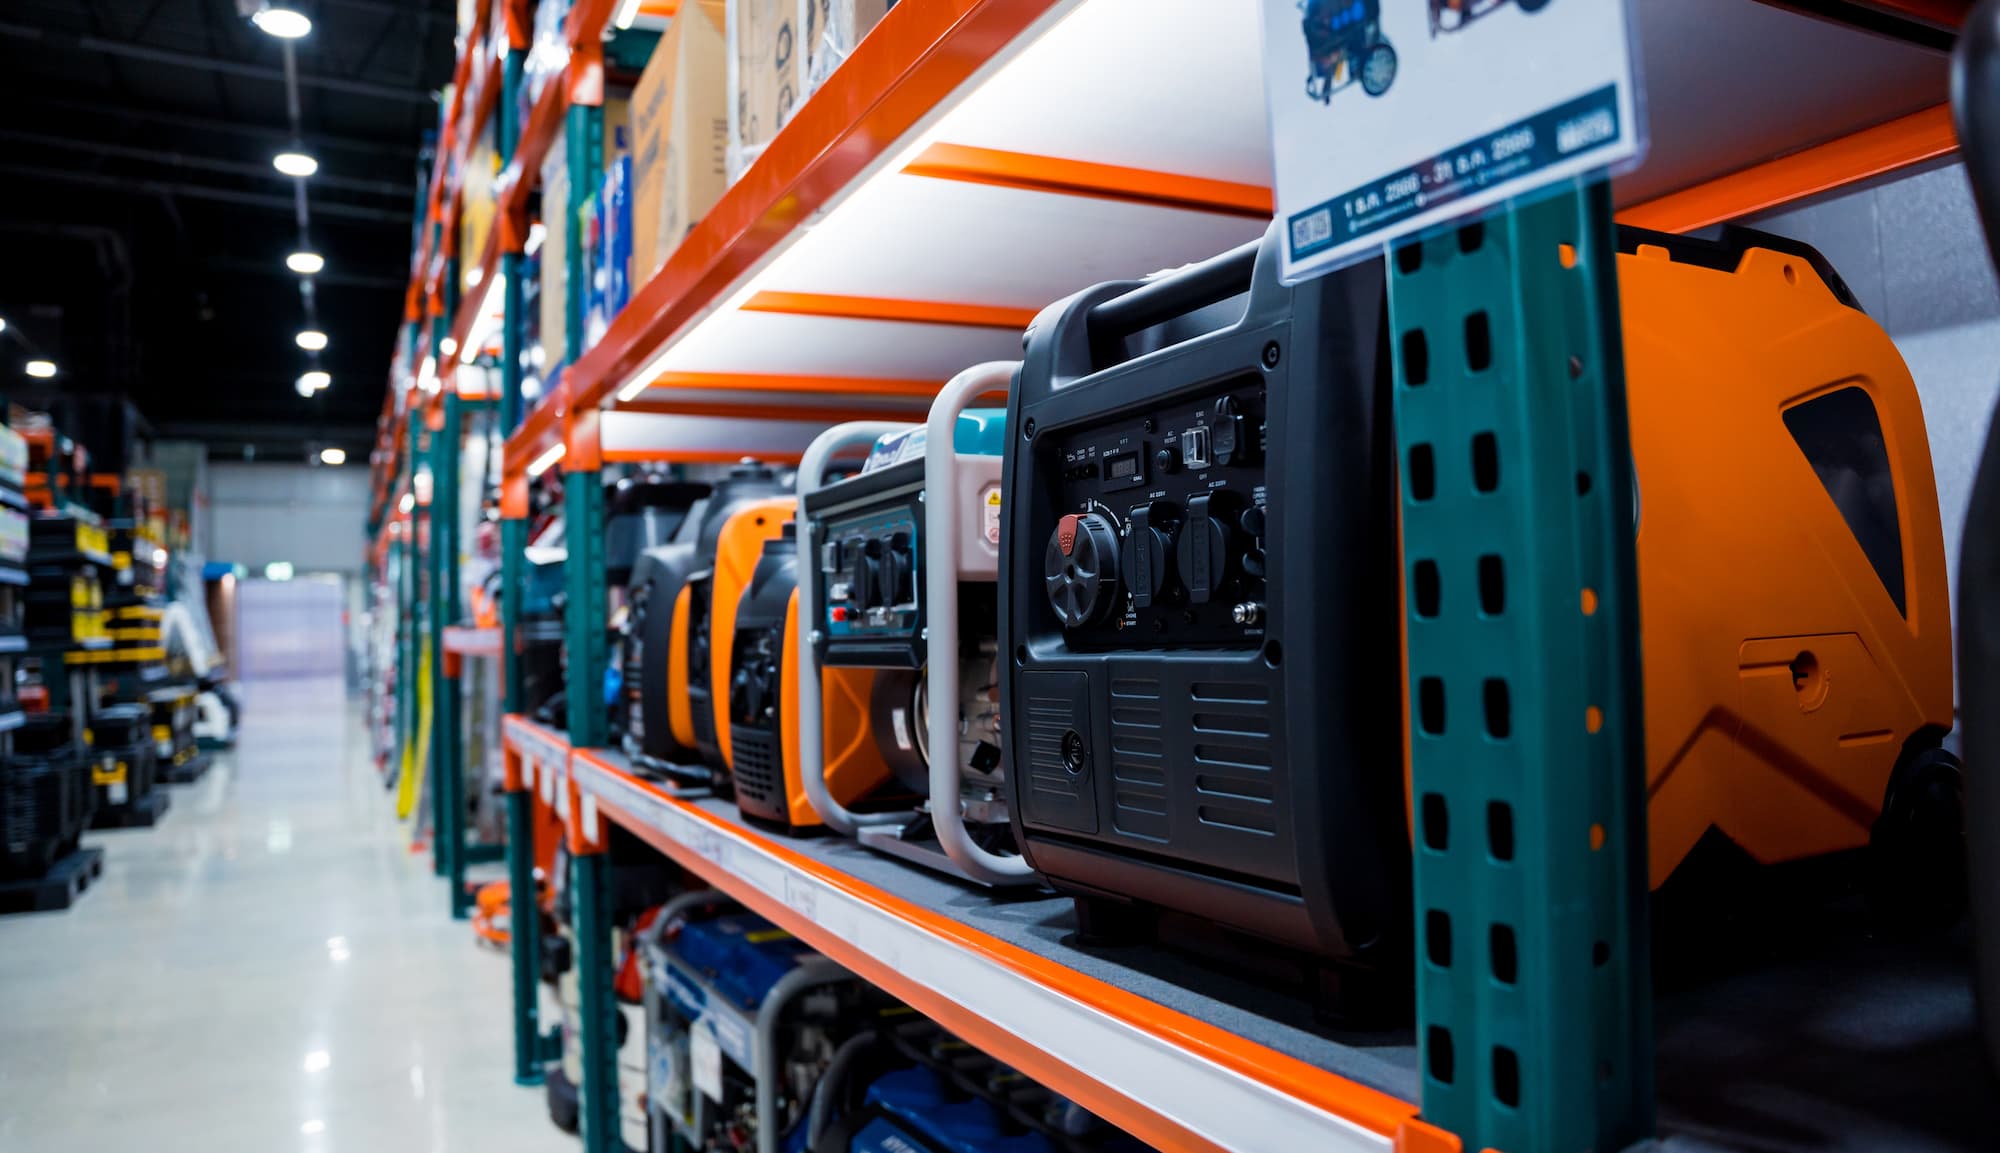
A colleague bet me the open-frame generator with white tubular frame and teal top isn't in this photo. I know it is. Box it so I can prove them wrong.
[798,388,1034,885]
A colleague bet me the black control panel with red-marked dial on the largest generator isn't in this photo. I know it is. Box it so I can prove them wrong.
[1044,376,1270,649]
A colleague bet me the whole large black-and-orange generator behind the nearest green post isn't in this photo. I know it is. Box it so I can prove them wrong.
[1002,230,1962,992]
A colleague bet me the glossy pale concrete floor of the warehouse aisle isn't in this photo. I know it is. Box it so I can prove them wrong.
[0,683,576,1153]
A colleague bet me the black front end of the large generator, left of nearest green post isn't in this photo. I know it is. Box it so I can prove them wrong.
[1000,230,1410,995]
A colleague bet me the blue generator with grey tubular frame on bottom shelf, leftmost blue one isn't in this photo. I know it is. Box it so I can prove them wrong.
[640,893,882,1153]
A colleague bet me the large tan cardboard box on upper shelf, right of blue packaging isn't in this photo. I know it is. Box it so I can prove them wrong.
[632,0,730,280]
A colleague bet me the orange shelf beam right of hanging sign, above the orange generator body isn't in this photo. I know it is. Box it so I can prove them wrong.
[1618,104,1958,232]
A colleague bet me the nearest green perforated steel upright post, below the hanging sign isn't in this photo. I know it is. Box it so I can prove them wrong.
[1388,180,1654,1153]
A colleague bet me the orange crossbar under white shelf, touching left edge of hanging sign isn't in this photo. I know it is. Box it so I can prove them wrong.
[902,144,1272,220]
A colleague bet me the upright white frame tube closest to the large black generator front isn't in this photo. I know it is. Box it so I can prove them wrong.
[928,360,1036,887]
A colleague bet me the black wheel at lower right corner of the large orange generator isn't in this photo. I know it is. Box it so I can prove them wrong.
[1868,739,1966,935]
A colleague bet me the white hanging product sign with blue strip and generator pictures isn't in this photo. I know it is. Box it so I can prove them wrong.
[1264,0,1644,282]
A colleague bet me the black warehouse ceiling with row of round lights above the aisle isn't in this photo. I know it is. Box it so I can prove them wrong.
[0,0,456,456]
